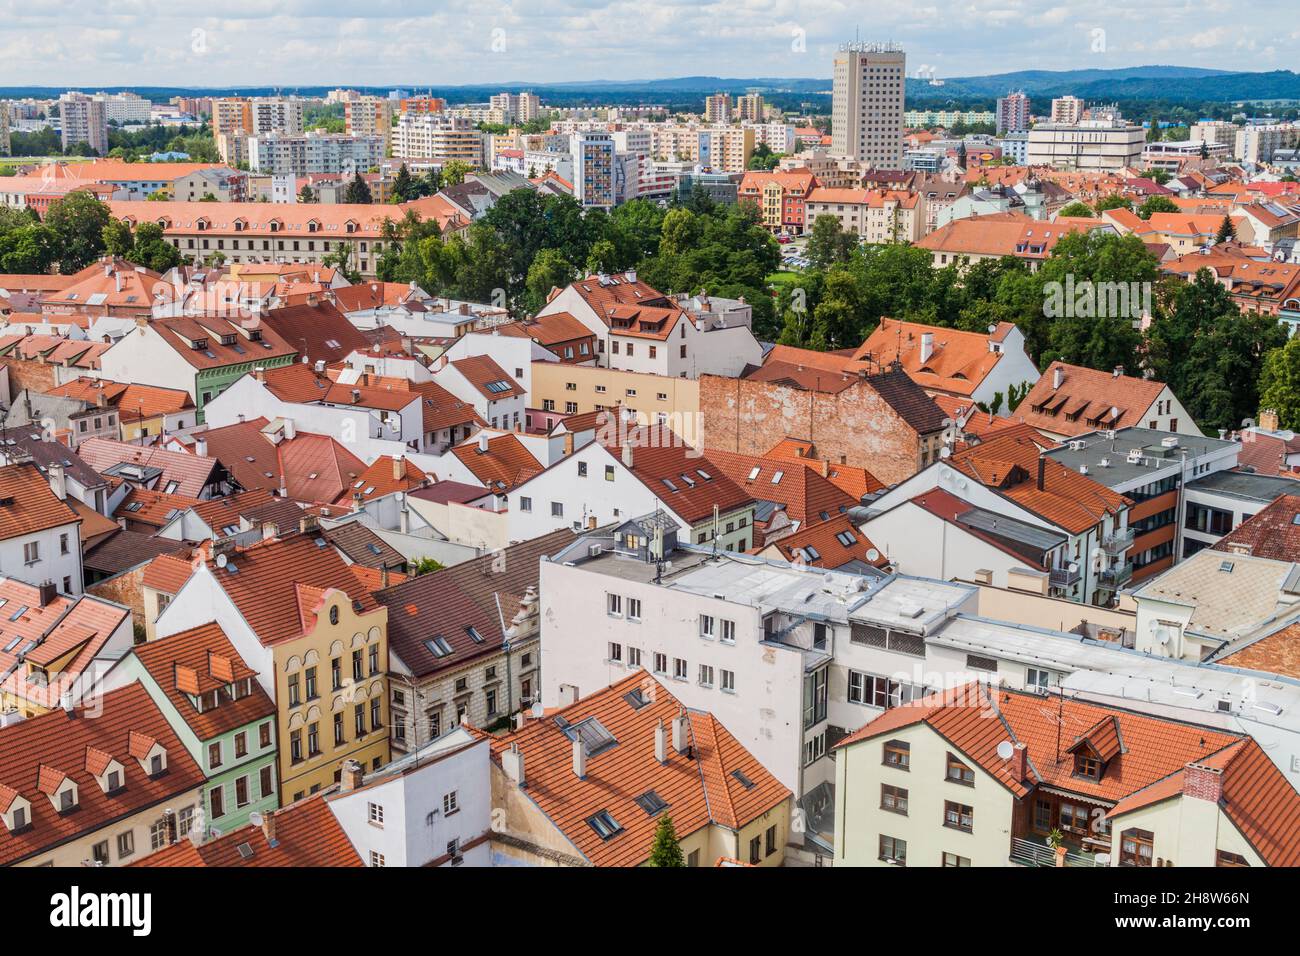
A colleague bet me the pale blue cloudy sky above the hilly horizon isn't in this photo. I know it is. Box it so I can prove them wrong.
[0,0,1300,87]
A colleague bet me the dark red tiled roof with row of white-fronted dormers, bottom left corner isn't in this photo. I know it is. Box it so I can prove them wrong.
[0,683,204,864]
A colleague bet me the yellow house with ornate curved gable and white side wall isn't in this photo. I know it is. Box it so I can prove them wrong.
[156,535,390,805]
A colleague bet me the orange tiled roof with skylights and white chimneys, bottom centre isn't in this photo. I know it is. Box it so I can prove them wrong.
[491,671,790,866]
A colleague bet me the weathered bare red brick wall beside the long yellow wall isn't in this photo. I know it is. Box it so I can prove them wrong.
[699,375,920,485]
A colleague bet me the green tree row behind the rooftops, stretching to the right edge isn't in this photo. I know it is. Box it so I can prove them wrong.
[777,219,1284,429]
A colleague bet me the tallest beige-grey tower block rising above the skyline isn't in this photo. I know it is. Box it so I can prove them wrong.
[831,43,907,169]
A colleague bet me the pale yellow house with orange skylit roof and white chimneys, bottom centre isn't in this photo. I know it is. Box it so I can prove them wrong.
[491,674,794,866]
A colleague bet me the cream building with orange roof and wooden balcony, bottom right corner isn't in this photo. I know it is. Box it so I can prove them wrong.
[835,684,1300,866]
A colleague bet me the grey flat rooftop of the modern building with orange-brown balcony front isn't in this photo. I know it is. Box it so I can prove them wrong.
[1044,428,1238,488]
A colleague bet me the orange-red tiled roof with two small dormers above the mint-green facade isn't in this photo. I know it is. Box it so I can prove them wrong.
[130,622,276,741]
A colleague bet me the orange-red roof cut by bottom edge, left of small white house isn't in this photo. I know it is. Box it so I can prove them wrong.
[131,793,365,868]
